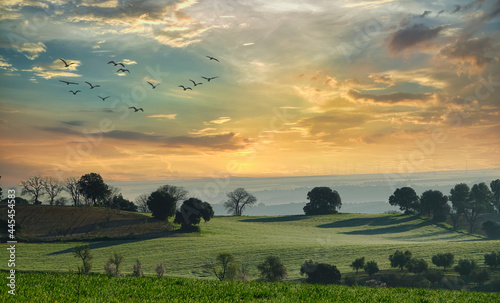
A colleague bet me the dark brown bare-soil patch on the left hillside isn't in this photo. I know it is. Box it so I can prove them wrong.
[0,205,173,241]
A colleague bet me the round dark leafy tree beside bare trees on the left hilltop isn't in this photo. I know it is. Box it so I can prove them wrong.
[78,173,109,206]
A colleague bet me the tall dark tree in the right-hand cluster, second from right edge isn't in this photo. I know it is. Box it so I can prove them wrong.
[464,182,493,233]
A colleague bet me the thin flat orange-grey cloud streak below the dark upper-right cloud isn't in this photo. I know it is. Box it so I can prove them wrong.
[347,89,433,104]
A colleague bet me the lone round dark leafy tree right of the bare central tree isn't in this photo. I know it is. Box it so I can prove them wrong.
[304,187,342,216]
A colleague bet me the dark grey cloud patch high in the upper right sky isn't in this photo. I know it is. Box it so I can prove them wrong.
[389,23,444,54]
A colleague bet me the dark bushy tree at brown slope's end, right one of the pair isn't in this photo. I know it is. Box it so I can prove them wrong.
[174,198,214,230]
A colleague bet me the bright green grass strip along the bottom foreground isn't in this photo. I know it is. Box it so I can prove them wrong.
[0,273,500,303]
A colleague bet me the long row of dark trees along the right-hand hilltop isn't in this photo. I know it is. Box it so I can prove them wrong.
[389,179,500,232]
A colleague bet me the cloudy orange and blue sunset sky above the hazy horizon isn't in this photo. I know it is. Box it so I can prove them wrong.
[0,0,500,184]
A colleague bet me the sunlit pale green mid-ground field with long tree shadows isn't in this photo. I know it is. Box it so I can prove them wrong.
[0,214,500,280]
